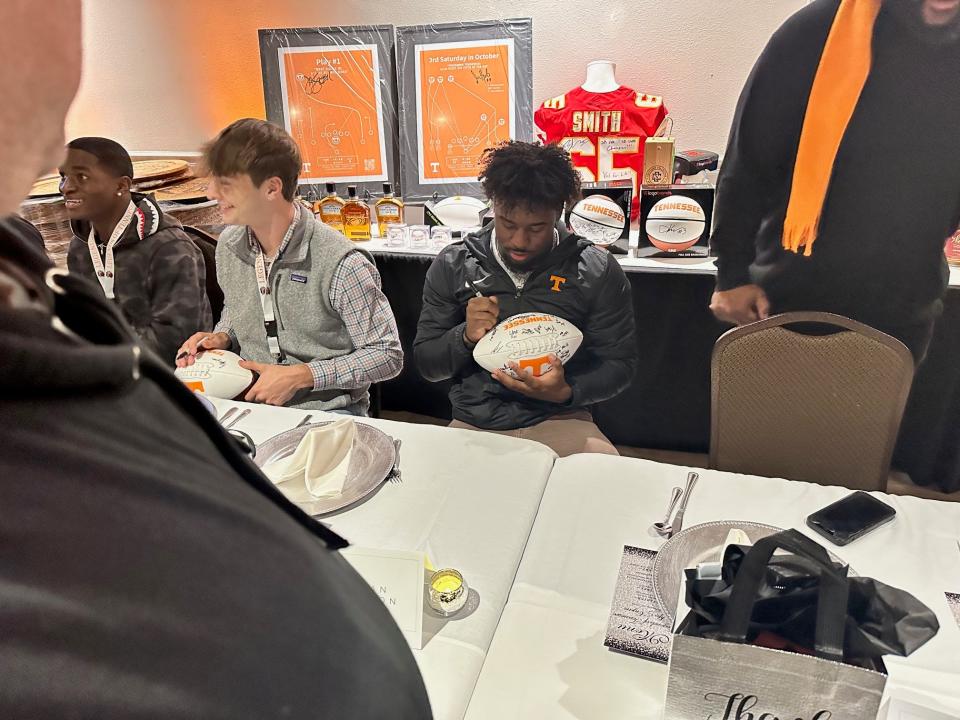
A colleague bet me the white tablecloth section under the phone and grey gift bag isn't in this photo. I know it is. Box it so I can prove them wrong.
[467,455,960,720]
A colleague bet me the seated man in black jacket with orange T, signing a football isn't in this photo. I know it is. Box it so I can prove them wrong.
[414,142,637,456]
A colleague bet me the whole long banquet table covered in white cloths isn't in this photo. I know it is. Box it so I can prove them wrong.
[199,400,960,720]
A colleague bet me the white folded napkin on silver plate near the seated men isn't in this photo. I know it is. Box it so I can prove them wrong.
[263,418,357,503]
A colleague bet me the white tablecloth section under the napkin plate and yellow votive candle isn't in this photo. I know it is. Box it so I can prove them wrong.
[214,400,556,720]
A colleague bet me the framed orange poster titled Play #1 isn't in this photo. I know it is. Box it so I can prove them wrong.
[260,25,399,199]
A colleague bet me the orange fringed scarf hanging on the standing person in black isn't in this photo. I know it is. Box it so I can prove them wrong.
[783,0,881,257]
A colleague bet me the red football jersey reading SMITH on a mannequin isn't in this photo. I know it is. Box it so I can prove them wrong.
[533,86,667,218]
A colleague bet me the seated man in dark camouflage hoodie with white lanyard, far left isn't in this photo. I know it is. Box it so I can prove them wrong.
[60,137,213,361]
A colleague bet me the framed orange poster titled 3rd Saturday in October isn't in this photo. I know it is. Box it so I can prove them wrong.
[397,19,533,199]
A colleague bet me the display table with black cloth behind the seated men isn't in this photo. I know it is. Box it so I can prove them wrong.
[362,240,960,492]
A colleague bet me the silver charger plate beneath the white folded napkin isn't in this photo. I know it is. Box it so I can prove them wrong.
[254,422,397,515]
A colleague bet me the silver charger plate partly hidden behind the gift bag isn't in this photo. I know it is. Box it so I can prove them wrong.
[653,520,856,626]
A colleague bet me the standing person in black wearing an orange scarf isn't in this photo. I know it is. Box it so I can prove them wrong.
[711,0,960,361]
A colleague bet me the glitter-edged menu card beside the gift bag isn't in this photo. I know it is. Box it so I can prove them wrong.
[603,545,672,663]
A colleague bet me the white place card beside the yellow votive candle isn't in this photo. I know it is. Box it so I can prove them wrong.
[340,546,424,650]
